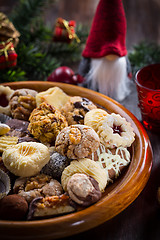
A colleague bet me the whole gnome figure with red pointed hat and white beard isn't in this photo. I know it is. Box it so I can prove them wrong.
[79,0,131,101]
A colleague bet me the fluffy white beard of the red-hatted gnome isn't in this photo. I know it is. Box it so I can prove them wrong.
[86,57,130,101]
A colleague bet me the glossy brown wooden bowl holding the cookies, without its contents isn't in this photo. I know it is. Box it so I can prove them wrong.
[0,81,152,240]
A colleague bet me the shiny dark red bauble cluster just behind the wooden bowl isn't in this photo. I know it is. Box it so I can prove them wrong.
[47,66,84,85]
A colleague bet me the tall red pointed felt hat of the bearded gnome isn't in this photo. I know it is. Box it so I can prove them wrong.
[82,0,127,58]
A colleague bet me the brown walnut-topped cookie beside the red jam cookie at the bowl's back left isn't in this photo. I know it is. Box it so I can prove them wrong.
[9,88,37,121]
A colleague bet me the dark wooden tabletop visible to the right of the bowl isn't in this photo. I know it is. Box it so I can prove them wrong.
[64,84,160,240]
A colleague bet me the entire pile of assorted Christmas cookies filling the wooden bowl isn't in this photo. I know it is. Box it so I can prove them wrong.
[0,86,135,220]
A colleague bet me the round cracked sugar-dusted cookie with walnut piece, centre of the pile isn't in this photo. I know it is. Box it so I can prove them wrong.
[55,124,100,159]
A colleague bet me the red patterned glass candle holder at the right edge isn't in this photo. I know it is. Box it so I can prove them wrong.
[135,64,160,132]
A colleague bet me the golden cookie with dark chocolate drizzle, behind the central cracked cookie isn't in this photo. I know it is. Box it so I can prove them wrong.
[61,96,97,125]
